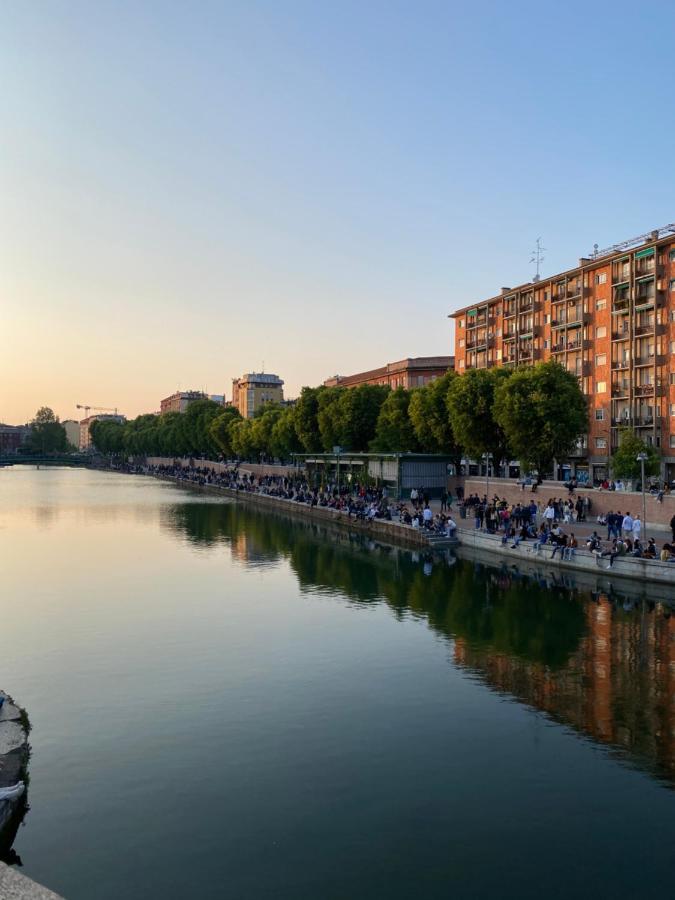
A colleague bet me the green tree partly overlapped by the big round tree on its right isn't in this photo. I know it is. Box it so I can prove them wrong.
[446,368,512,468]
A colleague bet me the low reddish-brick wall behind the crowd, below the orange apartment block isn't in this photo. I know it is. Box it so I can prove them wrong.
[449,477,675,530]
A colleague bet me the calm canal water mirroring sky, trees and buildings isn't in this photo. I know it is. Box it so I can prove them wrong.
[0,467,675,900]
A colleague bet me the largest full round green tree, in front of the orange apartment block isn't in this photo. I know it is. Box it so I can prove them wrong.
[493,361,588,475]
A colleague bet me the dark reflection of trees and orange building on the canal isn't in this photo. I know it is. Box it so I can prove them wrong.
[166,503,675,784]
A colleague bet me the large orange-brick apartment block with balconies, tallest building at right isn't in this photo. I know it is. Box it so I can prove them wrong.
[450,224,675,480]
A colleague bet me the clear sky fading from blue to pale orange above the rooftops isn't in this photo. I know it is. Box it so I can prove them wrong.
[0,0,675,424]
